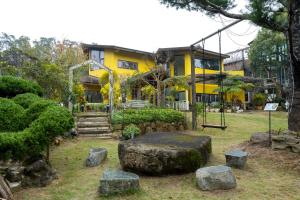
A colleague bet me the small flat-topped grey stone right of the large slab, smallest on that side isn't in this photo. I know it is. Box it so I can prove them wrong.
[225,150,248,169]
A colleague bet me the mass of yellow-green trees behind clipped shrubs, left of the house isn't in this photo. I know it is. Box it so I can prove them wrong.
[0,33,86,103]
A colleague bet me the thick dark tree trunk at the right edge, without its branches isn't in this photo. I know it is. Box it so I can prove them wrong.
[287,0,300,131]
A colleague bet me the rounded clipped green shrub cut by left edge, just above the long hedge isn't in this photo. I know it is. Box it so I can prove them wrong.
[0,98,25,131]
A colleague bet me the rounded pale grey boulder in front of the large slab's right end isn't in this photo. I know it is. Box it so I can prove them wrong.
[196,165,236,191]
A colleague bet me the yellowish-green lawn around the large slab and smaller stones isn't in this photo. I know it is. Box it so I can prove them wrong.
[16,112,300,200]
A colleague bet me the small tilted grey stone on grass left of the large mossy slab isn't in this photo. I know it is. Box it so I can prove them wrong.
[85,148,107,167]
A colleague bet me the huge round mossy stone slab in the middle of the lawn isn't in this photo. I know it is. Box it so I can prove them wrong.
[118,133,211,175]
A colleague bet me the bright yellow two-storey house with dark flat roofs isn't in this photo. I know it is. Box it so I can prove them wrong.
[82,44,244,107]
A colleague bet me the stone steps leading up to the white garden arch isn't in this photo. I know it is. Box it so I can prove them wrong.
[76,112,112,138]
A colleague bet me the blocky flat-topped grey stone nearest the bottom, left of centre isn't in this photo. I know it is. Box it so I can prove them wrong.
[100,170,140,195]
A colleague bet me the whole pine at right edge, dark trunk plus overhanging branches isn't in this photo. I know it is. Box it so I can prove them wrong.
[160,0,300,131]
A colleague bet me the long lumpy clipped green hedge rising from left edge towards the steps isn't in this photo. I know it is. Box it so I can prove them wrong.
[0,105,74,160]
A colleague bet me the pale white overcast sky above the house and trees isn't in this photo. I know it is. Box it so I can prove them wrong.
[0,0,259,53]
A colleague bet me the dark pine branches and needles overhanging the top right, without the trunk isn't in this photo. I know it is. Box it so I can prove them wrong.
[160,0,288,31]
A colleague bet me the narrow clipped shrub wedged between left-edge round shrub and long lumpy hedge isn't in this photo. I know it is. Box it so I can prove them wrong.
[24,99,57,125]
